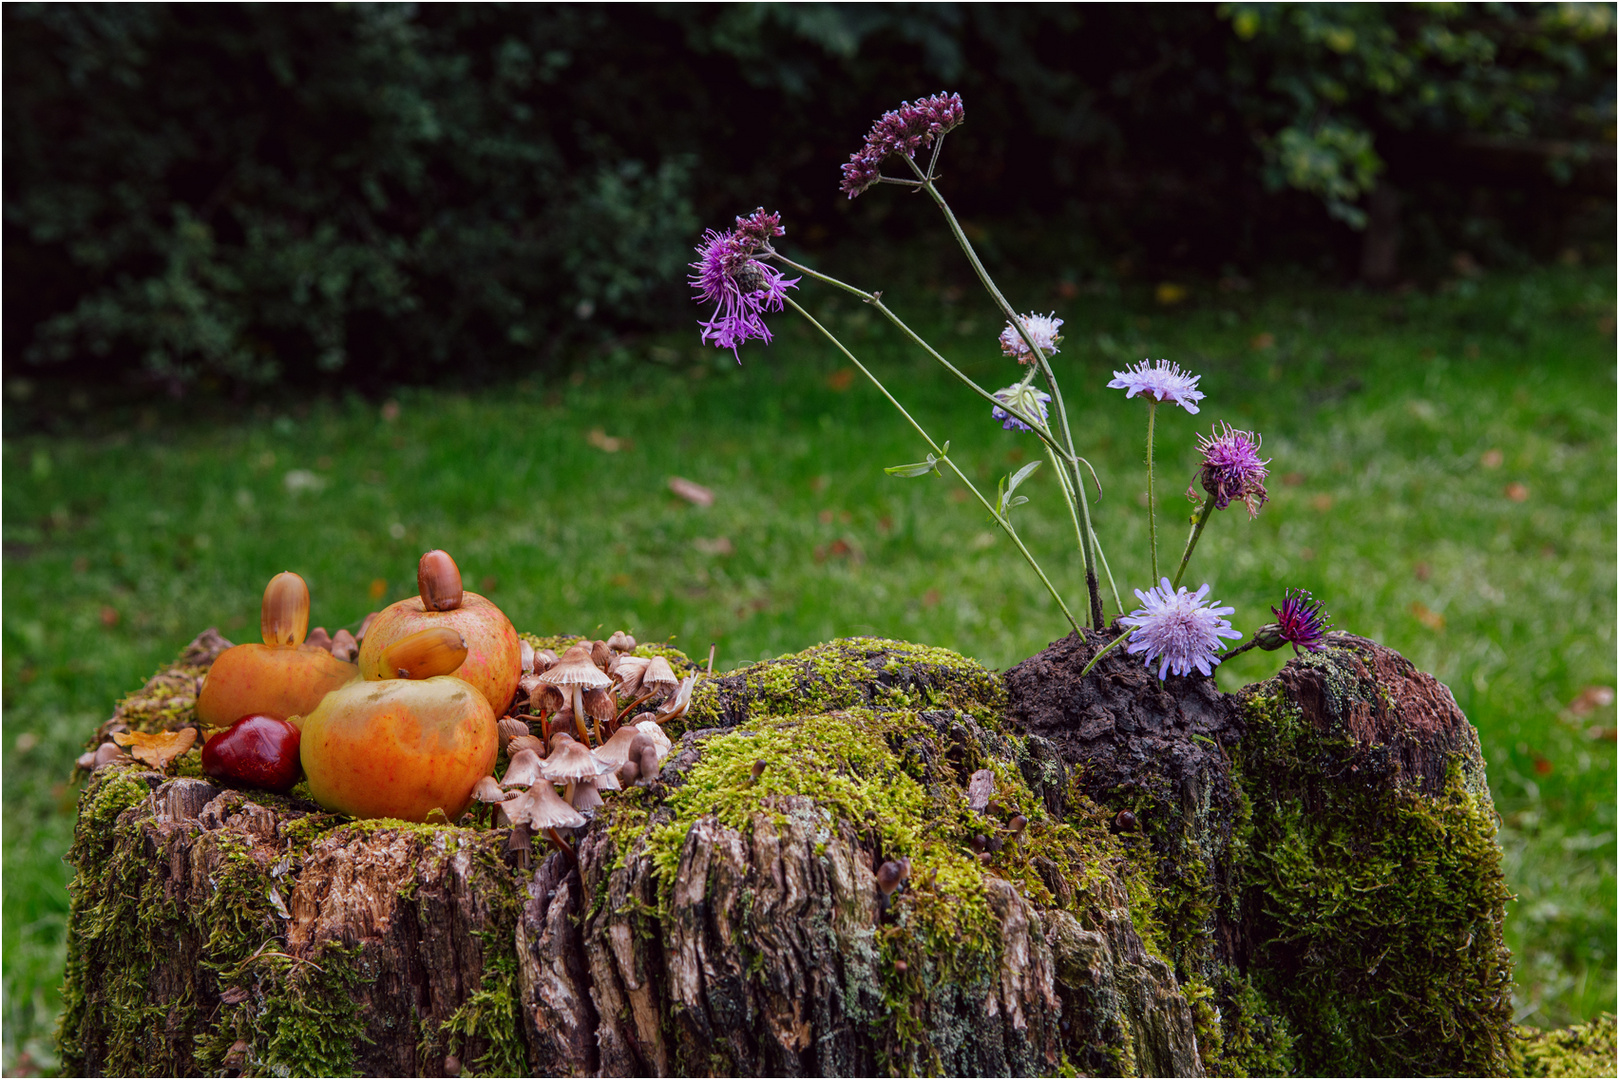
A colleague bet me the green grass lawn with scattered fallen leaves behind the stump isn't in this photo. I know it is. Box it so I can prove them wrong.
[0,255,1616,1070]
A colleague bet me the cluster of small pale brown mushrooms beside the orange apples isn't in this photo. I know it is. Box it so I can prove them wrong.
[473,630,696,858]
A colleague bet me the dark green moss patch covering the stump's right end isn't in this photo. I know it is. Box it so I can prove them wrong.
[1234,683,1511,1075]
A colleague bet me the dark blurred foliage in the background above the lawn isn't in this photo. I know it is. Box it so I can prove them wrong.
[0,3,1614,399]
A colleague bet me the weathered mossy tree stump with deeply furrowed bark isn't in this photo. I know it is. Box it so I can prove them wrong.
[58,633,1519,1075]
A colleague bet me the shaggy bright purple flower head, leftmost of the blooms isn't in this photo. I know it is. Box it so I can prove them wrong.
[691,207,800,364]
